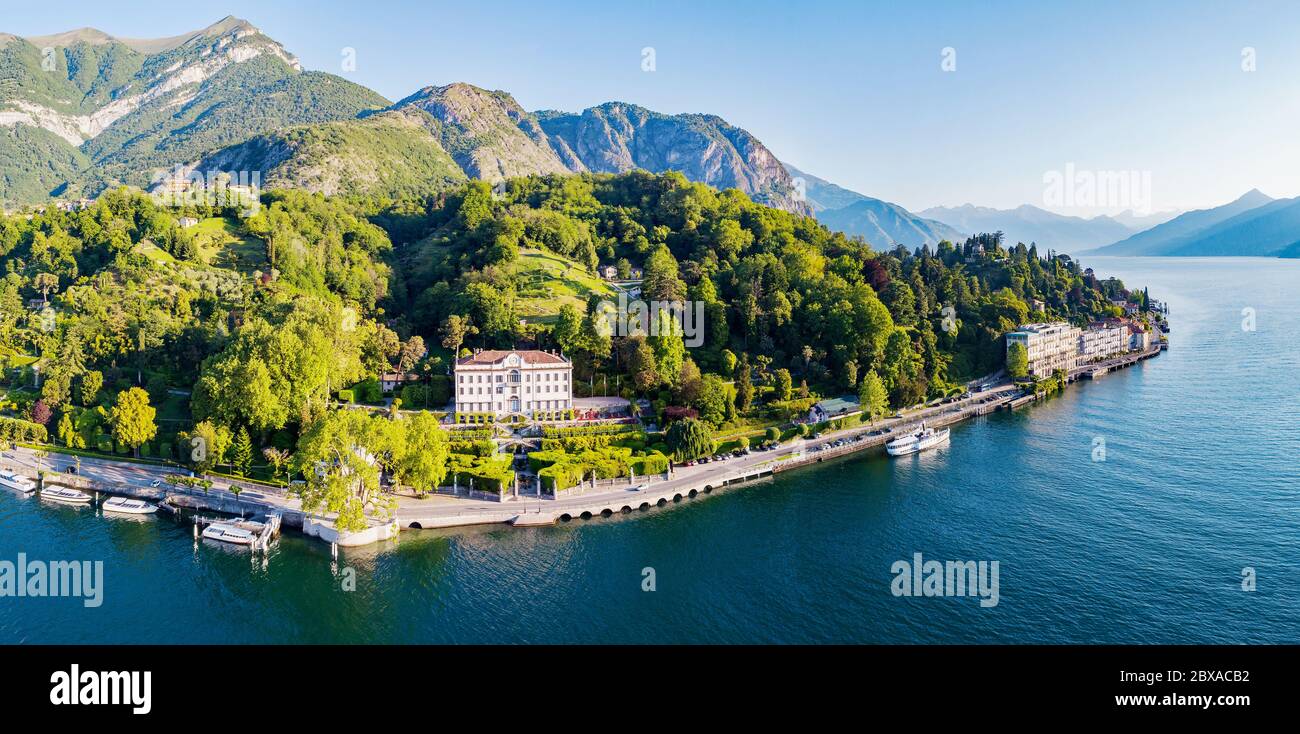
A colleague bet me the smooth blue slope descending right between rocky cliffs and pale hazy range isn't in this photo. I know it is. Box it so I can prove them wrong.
[784,164,966,249]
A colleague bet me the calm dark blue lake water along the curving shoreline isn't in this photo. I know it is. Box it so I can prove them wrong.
[0,259,1300,643]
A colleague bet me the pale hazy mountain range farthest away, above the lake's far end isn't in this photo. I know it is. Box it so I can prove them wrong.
[920,204,1132,252]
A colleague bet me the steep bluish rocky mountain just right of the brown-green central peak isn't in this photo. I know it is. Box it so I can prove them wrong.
[537,101,811,214]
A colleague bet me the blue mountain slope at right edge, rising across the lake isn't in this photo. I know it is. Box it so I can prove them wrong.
[1095,190,1300,257]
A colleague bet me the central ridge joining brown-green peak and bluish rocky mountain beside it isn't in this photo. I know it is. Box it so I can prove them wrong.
[199,83,810,214]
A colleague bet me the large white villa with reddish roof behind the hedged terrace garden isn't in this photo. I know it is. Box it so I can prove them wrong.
[452,349,573,418]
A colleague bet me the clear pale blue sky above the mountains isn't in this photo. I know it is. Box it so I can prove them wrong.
[10,0,1300,213]
